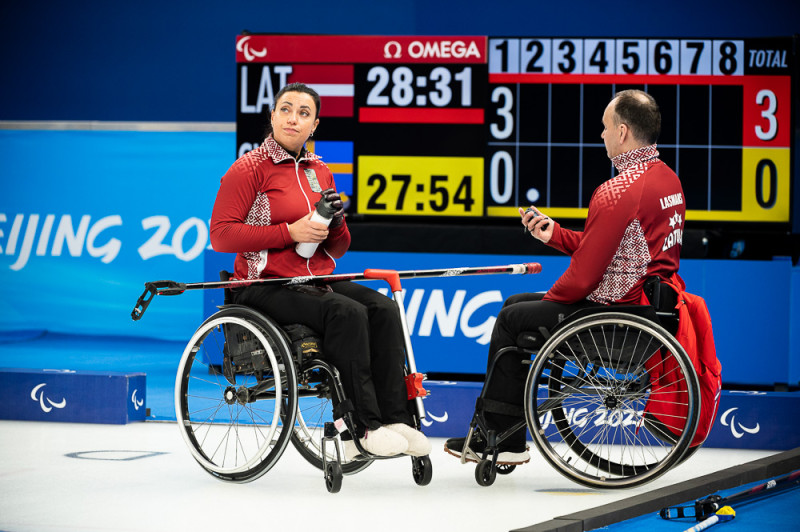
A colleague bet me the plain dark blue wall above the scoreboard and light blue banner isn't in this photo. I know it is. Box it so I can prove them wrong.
[0,0,800,122]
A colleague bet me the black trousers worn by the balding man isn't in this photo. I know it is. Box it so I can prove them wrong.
[484,293,602,451]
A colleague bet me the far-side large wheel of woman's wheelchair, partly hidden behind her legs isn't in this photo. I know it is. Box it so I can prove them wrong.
[291,369,373,475]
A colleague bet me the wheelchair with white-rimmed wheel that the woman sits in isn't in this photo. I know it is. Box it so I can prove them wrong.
[175,271,432,493]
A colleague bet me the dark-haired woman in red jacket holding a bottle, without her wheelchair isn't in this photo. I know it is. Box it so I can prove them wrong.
[211,83,430,459]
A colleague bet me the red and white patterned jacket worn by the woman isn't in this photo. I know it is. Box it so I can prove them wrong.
[211,135,350,279]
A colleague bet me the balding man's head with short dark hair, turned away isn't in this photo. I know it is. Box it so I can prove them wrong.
[600,90,661,159]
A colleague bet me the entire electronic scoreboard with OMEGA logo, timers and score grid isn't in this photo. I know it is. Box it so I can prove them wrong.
[236,34,797,226]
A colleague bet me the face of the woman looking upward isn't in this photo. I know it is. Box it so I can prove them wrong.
[271,92,319,154]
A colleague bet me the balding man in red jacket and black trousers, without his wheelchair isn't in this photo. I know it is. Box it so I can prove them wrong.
[445,90,685,466]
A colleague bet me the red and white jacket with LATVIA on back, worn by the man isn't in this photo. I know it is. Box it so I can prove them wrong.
[544,144,686,304]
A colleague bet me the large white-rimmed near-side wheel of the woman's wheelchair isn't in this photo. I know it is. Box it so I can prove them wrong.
[175,305,297,482]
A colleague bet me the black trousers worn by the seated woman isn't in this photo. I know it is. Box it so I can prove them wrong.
[233,281,412,437]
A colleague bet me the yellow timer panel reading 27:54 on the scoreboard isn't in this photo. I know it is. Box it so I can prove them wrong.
[357,155,483,216]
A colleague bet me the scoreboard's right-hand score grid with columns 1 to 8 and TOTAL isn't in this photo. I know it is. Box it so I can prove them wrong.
[485,38,795,222]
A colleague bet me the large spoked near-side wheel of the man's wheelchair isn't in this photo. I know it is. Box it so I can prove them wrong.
[525,312,700,488]
